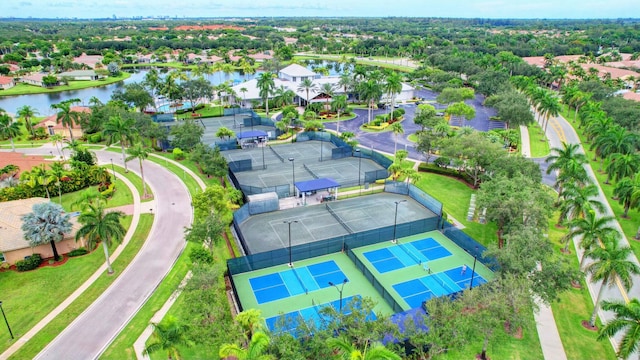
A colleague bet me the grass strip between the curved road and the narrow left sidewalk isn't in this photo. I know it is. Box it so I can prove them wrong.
[10,214,154,359]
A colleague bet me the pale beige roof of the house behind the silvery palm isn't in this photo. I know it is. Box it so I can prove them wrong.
[0,198,79,252]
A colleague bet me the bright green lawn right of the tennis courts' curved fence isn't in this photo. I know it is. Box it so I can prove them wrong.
[416,172,497,246]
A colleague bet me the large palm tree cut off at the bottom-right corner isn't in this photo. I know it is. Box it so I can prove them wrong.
[598,298,640,359]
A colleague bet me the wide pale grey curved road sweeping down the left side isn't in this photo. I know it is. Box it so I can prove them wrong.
[13,147,192,360]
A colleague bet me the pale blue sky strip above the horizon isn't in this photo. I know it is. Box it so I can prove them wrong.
[0,0,640,19]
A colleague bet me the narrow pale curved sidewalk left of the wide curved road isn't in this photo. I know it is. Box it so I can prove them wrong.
[0,168,141,360]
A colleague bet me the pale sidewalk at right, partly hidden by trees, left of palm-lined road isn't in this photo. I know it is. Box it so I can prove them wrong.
[520,125,567,360]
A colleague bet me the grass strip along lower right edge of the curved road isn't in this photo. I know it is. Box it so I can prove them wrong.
[100,242,196,360]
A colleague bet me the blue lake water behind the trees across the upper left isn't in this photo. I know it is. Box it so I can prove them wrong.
[0,62,339,116]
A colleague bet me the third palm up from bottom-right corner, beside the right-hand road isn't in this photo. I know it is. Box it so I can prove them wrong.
[563,209,619,270]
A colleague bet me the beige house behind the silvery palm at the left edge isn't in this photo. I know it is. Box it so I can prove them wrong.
[0,198,84,265]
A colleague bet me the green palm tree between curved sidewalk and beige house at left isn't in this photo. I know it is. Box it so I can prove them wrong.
[76,202,126,274]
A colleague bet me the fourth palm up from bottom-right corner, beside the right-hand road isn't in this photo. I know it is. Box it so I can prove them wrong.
[557,184,605,225]
